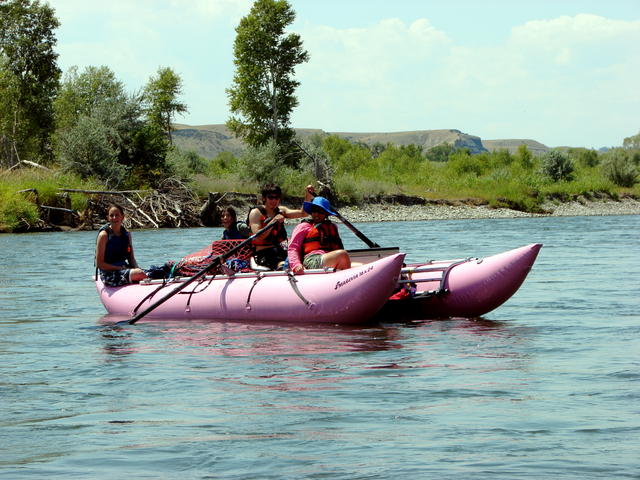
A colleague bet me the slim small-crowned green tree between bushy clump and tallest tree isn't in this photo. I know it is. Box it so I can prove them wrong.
[144,67,187,145]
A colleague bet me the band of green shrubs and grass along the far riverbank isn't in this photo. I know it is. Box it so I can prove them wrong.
[0,137,640,232]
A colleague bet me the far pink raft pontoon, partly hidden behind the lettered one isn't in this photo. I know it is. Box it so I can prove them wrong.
[352,243,542,320]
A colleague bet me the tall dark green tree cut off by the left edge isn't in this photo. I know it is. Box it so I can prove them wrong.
[0,0,60,165]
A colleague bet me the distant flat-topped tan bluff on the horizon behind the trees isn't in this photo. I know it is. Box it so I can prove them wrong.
[173,124,549,158]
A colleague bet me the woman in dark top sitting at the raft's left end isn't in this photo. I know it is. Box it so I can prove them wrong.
[96,204,147,287]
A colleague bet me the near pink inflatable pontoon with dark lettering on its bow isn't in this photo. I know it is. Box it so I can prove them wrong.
[96,253,404,324]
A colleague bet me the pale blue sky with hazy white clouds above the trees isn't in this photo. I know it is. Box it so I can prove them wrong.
[48,0,640,148]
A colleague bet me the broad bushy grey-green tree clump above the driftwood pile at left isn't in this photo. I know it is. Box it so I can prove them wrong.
[56,66,169,187]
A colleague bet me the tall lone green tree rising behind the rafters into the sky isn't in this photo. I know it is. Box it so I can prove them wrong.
[227,0,309,158]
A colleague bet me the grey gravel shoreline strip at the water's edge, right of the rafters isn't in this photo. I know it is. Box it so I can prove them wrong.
[330,198,640,222]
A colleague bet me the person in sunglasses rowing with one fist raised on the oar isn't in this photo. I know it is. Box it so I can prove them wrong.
[247,184,315,270]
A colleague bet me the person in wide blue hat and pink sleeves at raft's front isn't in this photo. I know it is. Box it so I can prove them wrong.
[288,197,351,275]
